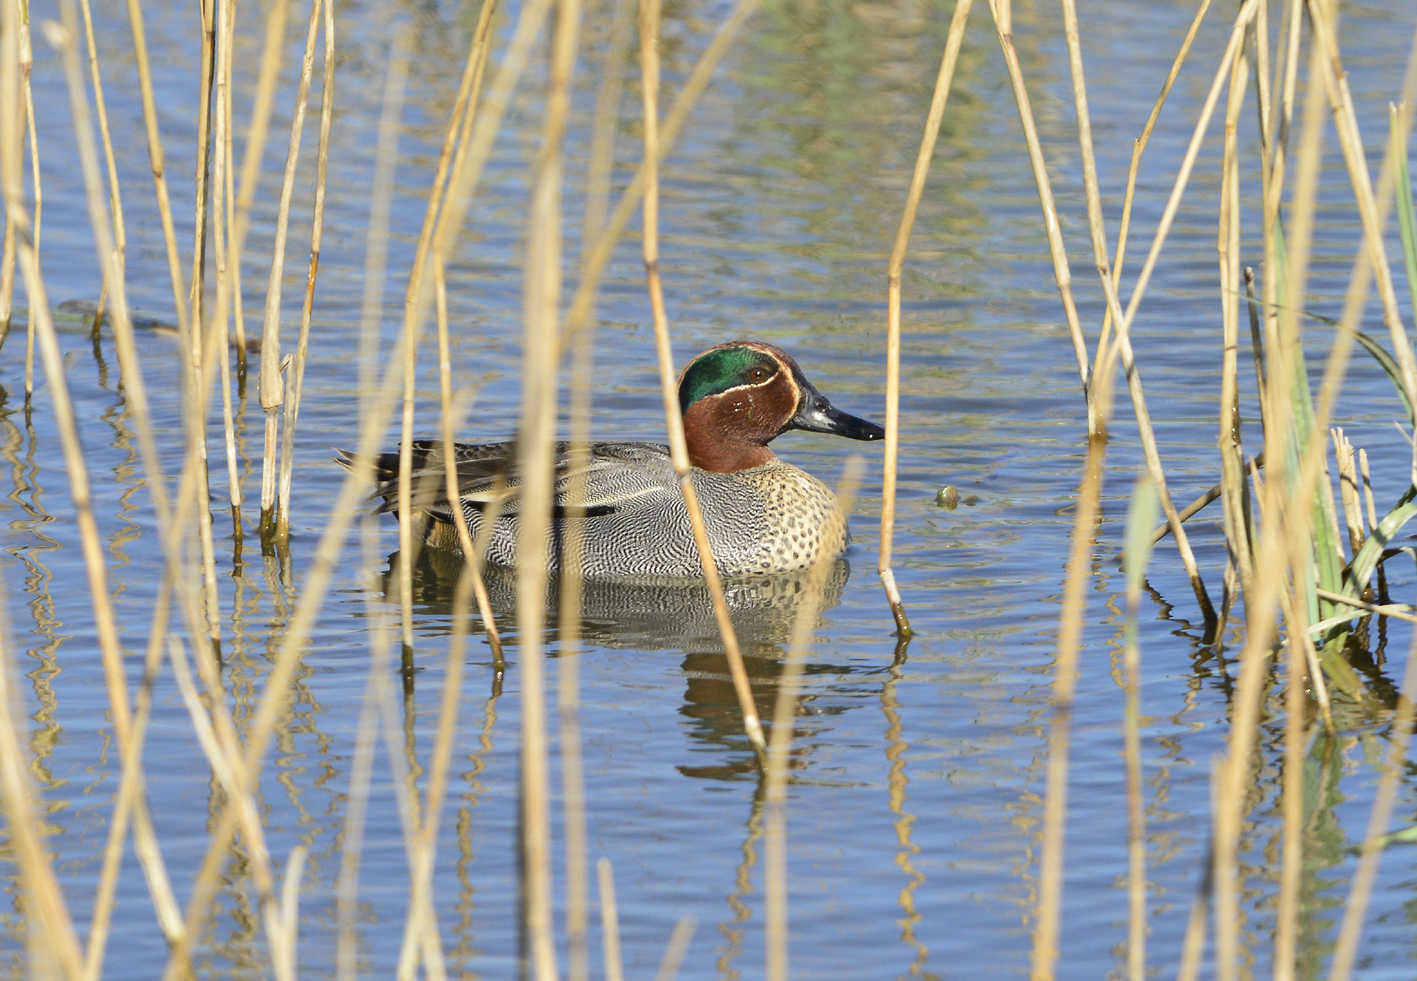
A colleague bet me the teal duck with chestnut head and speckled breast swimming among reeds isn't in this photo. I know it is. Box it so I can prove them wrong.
[337,340,886,580]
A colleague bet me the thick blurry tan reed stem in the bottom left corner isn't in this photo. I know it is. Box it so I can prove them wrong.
[0,623,84,981]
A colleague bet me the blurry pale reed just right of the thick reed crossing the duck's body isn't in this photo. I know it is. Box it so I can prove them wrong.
[557,0,635,981]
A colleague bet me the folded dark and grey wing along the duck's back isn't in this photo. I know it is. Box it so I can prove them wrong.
[340,439,677,522]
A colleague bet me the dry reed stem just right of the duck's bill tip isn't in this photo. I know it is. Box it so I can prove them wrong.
[876,0,974,637]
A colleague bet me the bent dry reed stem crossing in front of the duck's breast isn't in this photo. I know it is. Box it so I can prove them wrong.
[639,0,767,756]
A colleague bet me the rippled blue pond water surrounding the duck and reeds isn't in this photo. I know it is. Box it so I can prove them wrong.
[0,1,1417,978]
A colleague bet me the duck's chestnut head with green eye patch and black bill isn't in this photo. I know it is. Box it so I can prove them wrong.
[679,340,886,473]
